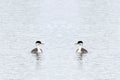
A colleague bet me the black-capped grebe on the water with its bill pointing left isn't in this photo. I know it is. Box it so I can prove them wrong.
[75,41,88,59]
